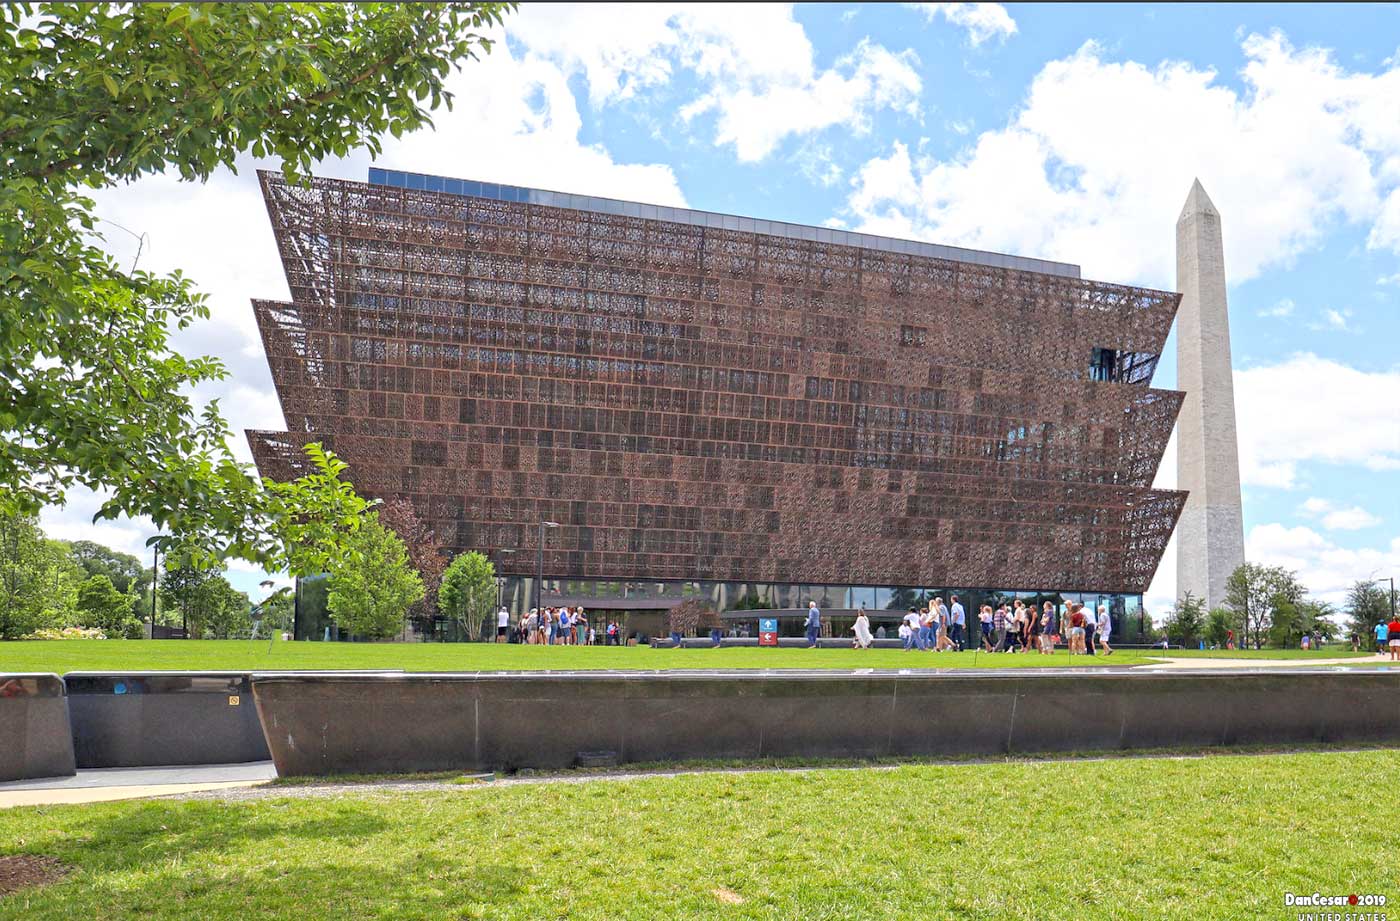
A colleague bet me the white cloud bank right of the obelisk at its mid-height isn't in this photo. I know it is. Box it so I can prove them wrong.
[1235,353,1400,488]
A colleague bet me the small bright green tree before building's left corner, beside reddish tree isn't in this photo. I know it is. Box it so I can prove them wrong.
[329,514,423,637]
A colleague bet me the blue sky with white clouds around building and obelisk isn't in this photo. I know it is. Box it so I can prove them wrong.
[42,3,1400,617]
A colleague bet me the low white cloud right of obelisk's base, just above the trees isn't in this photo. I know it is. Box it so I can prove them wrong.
[1245,523,1400,605]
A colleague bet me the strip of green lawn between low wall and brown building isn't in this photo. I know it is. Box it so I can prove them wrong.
[0,640,1147,673]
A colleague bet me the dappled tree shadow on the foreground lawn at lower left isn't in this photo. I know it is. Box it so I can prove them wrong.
[0,801,529,921]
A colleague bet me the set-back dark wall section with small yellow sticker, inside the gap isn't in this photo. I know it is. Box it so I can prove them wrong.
[63,672,269,767]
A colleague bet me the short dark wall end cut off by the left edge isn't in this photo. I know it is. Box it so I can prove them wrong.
[0,673,74,781]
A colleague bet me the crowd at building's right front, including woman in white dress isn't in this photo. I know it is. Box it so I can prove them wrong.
[853,595,1113,655]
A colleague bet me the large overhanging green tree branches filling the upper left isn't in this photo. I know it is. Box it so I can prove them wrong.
[0,3,507,567]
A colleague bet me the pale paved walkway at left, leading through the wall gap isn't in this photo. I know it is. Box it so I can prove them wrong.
[0,761,277,809]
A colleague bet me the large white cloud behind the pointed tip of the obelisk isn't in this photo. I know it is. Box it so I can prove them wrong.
[848,34,1400,287]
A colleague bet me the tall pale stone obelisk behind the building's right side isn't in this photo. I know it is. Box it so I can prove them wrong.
[1176,179,1245,609]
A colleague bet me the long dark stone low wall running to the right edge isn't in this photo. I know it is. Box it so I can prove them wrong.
[253,669,1400,775]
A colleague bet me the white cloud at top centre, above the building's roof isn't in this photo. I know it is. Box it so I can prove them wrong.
[510,4,923,162]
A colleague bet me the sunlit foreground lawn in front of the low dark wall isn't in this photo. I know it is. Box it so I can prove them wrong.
[0,750,1400,921]
